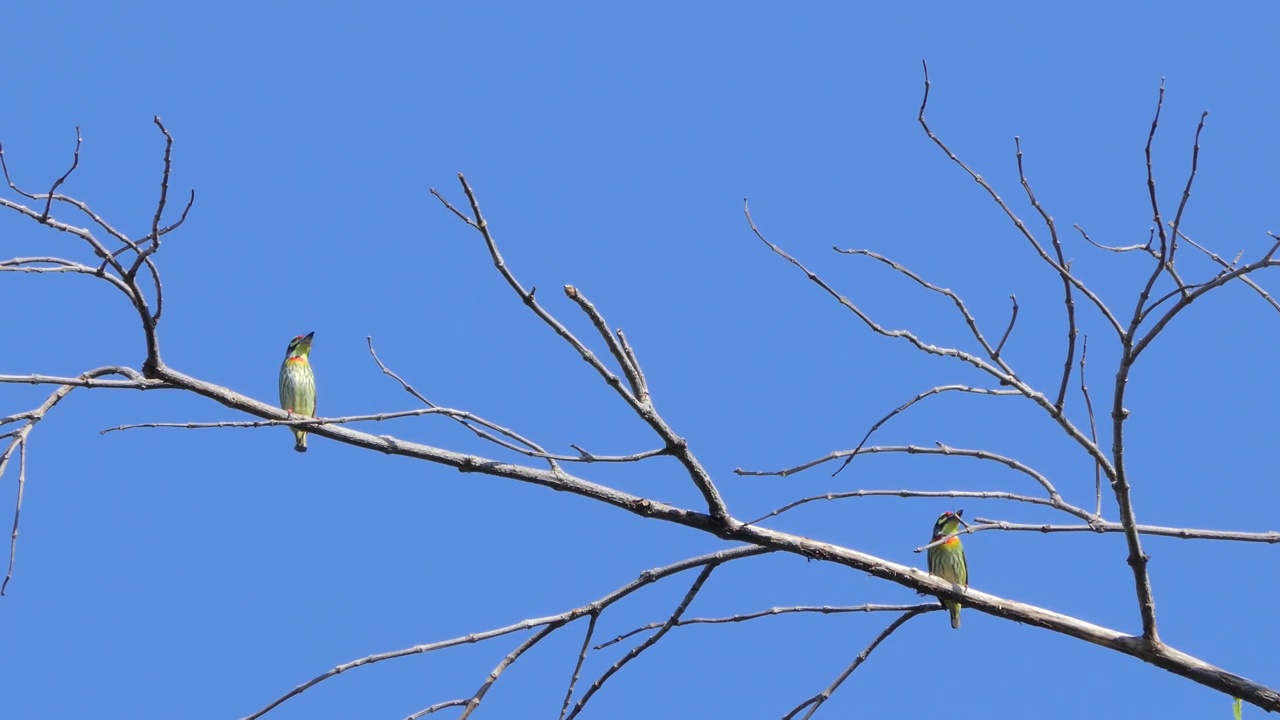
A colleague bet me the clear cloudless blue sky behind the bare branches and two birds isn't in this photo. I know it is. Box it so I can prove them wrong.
[0,3,1280,719]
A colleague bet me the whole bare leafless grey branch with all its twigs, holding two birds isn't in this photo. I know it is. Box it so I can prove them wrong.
[10,113,1280,717]
